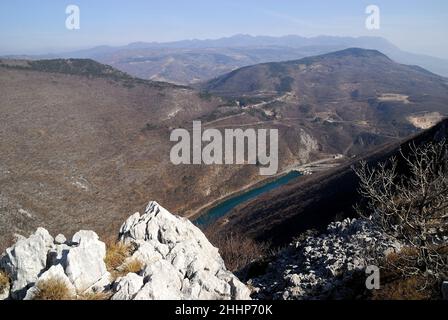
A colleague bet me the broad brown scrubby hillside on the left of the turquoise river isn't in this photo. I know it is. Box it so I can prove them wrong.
[0,60,242,248]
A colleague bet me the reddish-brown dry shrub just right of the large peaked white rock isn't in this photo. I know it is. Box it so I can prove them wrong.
[207,233,268,272]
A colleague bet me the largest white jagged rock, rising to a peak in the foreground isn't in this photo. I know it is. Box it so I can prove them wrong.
[120,202,249,300]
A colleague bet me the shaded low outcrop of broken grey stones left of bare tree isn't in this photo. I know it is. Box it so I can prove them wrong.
[249,219,401,300]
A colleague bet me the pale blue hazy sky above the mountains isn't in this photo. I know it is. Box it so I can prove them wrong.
[0,0,448,59]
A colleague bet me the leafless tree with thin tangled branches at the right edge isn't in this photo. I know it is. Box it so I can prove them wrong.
[354,141,448,281]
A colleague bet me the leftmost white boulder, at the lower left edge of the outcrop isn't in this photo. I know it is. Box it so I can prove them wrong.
[0,228,53,298]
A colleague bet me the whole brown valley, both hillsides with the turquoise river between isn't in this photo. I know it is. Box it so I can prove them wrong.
[0,49,448,252]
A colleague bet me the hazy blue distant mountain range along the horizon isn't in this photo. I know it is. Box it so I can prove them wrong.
[5,35,448,84]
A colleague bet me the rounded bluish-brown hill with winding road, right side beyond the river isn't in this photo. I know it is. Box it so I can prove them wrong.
[203,48,448,154]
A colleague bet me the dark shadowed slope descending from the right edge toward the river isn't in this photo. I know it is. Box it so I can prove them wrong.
[211,120,448,245]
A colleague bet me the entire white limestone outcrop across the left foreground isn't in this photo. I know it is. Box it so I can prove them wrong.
[0,202,250,300]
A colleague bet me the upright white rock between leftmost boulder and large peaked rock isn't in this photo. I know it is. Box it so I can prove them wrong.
[65,231,107,293]
